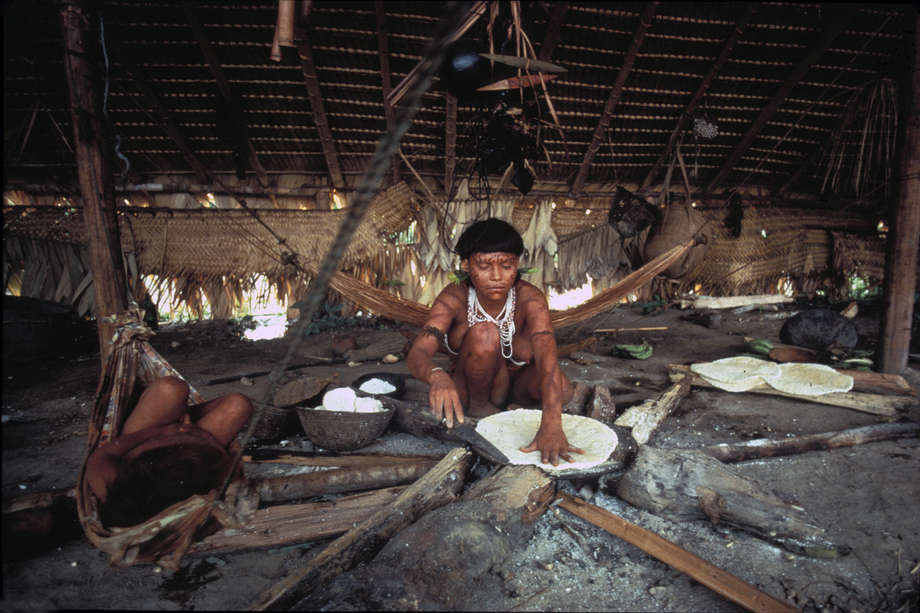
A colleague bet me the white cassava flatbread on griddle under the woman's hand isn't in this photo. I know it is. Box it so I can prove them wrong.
[476,409,617,472]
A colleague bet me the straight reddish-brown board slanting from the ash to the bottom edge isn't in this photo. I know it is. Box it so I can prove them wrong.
[559,492,798,612]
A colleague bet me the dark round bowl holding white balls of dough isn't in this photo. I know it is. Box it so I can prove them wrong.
[296,407,396,451]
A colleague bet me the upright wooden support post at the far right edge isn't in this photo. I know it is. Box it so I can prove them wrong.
[878,7,920,373]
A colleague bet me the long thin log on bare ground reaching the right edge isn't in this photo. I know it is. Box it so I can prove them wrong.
[700,422,920,462]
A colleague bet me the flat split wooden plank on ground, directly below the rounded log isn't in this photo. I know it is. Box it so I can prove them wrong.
[189,486,406,553]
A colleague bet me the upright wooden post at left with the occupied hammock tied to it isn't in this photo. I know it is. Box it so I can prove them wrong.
[60,1,128,366]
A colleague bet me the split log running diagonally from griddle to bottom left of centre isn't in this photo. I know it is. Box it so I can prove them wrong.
[250,448,473,610]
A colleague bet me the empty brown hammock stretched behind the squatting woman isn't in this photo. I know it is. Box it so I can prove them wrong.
[329,239,696,329]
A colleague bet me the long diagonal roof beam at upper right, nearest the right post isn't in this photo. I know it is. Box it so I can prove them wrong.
[706,4,856,193]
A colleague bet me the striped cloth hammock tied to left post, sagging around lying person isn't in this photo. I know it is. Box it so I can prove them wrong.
[76,309,234,570]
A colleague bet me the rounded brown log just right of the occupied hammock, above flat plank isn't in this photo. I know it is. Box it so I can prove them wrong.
[253,459,437,502]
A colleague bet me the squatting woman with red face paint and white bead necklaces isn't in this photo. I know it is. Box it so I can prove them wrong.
[407,218,583,466]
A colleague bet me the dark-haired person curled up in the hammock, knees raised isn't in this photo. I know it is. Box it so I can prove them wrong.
[86,377,252,526]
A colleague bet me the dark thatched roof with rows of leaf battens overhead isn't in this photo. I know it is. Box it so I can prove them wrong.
[4,0,912,207]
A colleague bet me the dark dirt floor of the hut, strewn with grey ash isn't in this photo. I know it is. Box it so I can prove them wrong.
[2,298,920,613]
